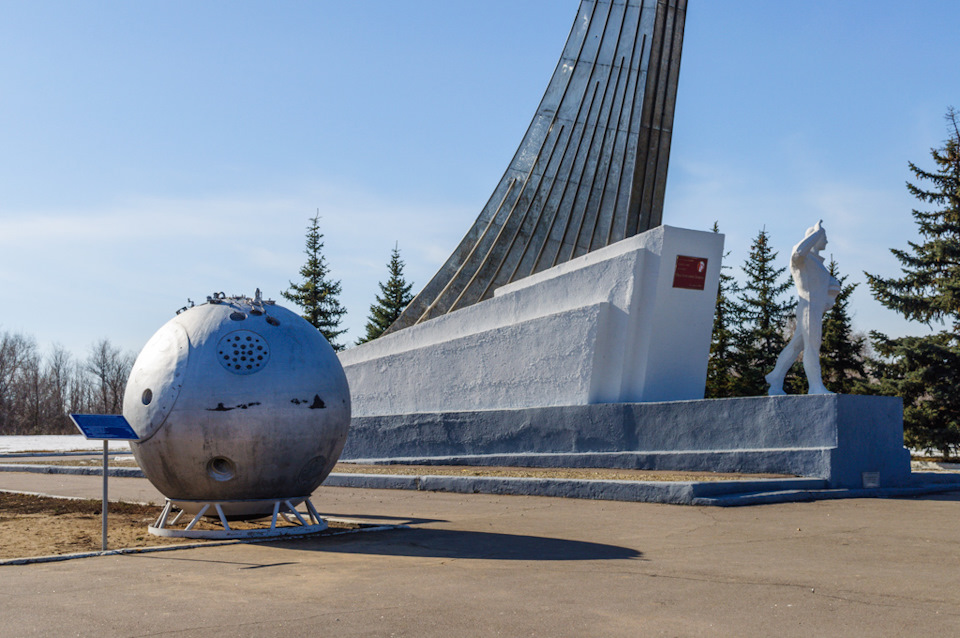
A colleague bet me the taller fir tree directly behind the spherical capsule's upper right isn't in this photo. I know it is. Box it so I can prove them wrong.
[280,211,347,350]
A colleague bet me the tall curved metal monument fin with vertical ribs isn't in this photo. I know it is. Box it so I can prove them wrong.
[388,0,687,332]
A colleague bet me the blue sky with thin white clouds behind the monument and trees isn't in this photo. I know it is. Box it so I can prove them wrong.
[0,0,960,356]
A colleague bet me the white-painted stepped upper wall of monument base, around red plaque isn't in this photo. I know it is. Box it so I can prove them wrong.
[339,226,723,416]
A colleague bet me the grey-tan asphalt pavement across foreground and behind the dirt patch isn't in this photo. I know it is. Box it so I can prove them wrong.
[0,473,960,638]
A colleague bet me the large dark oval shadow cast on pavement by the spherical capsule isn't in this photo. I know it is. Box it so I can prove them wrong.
[270,529,643,561]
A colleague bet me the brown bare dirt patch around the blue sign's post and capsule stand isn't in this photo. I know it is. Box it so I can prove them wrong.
[0,492,359,560]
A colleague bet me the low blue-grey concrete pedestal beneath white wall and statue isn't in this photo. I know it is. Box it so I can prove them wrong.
[341,395,910,488]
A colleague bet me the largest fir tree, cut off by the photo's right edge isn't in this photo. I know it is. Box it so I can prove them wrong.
[867,108,960,456]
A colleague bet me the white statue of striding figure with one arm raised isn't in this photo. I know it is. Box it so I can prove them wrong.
[765,219,840,396]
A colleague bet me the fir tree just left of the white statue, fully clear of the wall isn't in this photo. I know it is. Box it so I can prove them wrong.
[734,229,796,396]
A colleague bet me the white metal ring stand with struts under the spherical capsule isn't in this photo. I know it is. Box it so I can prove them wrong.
[147,497,327,540]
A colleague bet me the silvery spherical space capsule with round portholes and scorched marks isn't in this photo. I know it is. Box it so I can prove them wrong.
[123,294,350,519]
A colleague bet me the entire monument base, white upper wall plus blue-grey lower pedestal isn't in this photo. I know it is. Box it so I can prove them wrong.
[339,226,910,488]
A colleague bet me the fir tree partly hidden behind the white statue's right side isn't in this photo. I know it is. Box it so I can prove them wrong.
[816,258,867,394]
